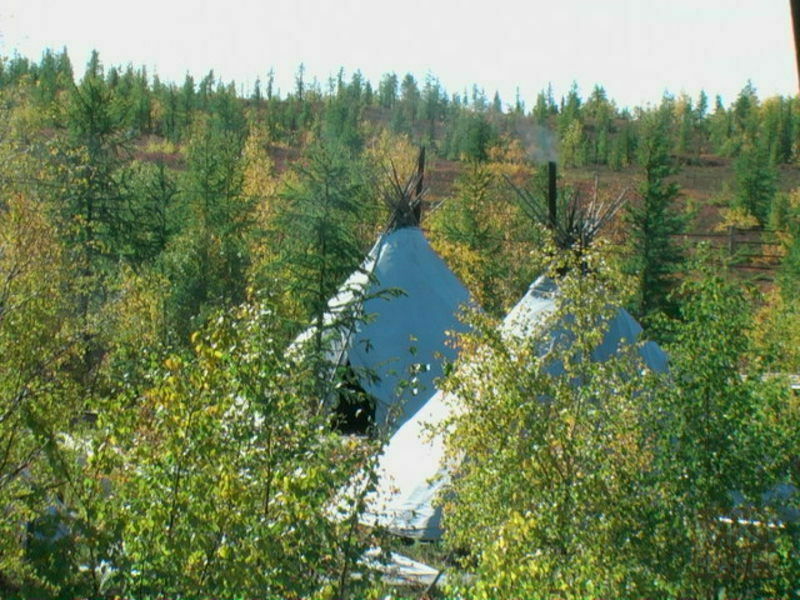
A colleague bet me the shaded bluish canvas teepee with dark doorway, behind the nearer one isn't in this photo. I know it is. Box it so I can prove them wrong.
[294,226,469,428]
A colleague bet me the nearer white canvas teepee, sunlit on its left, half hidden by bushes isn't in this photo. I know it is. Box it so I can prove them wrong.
[362,277,667,540]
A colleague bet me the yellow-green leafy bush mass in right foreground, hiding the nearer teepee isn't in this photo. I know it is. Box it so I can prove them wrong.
[438,246,800,598]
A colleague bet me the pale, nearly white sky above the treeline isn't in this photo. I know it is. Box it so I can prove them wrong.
[0,0,798,106]
